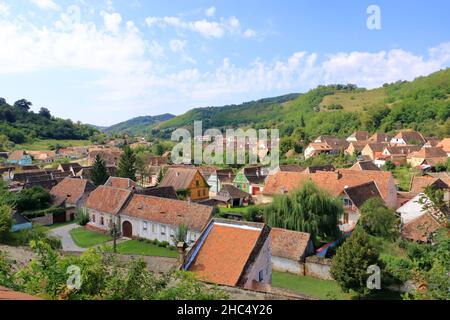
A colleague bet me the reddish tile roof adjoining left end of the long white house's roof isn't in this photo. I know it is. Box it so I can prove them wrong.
[86,186,131,214]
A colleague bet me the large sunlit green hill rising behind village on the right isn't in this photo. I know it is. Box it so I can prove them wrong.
[152,69,450,141]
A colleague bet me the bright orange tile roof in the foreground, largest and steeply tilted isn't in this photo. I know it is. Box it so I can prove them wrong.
[189,223,261,286]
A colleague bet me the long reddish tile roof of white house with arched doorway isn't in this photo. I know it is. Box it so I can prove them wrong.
[121,194,213,231]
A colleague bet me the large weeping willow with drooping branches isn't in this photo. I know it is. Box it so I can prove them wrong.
[264,182,344,244]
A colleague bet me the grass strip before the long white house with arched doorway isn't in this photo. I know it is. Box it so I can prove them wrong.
[106,240,178,258]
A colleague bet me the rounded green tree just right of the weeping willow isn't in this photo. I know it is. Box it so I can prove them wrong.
[358,197,399,239]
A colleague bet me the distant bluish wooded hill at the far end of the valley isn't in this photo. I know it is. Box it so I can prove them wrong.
[103,113,175,135]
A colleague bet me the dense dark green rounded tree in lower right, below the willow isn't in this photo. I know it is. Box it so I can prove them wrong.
[330,230,379,296]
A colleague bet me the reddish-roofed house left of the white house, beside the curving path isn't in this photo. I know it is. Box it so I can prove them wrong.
[50,178,95,221]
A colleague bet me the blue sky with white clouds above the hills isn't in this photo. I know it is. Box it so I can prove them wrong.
[0,0,450,125]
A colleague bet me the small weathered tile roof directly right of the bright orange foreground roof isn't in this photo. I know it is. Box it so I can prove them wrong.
[270,228,311,261]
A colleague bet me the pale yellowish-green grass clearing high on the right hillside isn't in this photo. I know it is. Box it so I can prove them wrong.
[320,88,386,111]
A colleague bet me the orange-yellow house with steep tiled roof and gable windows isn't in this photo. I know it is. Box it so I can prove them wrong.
[159,167,209,201]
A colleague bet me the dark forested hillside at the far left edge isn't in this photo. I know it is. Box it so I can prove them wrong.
[0,98,97,149]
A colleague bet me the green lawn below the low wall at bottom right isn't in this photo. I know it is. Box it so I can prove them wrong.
[272,271,352,300]
